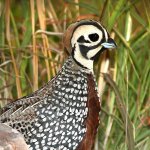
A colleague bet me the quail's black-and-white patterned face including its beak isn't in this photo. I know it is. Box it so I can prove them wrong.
[71,21,116,70]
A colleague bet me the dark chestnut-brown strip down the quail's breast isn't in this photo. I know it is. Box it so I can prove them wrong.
[77,74,100,150]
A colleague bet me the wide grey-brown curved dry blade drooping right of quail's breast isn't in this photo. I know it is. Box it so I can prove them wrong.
[103,73,135,150]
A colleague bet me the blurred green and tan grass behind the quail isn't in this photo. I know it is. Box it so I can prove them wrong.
[0,0,150,150]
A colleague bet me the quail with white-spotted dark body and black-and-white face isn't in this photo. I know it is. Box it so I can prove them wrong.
[0,20,116,150]
